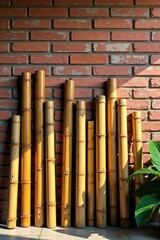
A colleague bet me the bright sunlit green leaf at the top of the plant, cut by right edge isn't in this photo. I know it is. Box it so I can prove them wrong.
[149,141,160,171]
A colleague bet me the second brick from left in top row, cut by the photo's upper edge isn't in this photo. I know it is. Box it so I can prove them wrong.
[13,0,52,6]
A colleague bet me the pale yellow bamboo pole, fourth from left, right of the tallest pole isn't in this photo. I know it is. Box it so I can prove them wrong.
[45,101,56,228]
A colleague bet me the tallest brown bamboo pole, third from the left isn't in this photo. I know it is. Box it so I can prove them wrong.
[35,70,45,227]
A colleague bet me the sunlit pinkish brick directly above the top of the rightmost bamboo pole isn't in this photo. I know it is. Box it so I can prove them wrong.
[127,99,150,110]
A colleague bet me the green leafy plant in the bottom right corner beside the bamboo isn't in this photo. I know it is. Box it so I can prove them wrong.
[128,141,160,227]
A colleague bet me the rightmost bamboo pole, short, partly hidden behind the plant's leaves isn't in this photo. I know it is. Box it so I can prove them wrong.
[132,111,143,205]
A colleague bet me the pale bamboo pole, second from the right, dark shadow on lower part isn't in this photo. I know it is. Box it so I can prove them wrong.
[118,99,130,228]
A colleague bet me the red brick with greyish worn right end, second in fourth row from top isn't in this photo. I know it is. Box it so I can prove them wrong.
[31,31,68,41]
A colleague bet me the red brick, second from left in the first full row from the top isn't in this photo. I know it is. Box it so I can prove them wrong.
[29,7,68,18]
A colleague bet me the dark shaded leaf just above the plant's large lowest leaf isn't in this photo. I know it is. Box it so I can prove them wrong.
[134,180,160,197]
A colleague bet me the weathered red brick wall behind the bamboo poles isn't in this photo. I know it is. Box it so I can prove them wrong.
[0,0,160,223]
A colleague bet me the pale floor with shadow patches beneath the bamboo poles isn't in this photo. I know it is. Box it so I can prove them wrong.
[0,225,160,240]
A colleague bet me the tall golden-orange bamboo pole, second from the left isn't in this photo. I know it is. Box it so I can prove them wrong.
[21,72,31,227]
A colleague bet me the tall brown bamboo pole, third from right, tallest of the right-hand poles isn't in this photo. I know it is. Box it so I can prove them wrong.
[107,78,118,226]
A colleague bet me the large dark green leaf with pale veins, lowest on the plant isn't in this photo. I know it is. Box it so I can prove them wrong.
[135,194,160,227]
